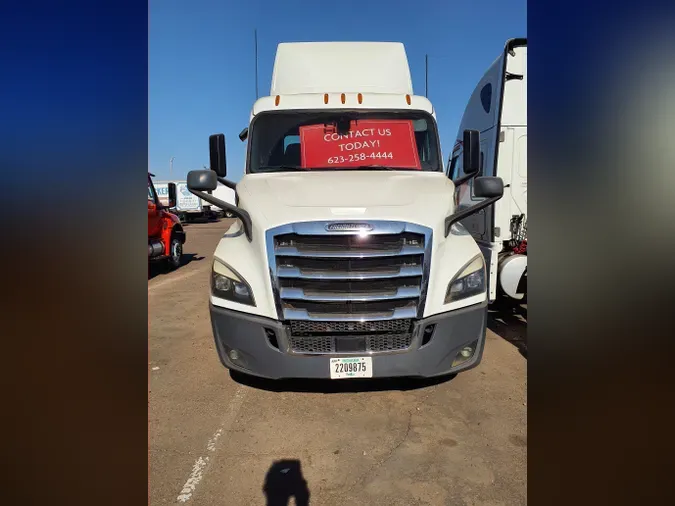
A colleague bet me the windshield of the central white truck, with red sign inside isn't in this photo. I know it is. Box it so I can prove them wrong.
[248,111,442,173]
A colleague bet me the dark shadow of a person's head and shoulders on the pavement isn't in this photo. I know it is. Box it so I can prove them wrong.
[263,460,309,506]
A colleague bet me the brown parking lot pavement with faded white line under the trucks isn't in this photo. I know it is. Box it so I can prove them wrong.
[148,220,527,506]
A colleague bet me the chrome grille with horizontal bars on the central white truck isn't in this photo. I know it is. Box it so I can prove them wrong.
[267,221,431,322]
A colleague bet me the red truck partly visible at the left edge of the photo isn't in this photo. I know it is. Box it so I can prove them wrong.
[148,172,186,269]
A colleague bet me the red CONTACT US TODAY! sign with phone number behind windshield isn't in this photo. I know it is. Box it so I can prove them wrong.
[300,120,421,170]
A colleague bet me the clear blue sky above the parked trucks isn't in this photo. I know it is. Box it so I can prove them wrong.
[148,0,527,181]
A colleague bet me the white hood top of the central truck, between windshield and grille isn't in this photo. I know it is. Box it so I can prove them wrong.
[237,170,454,232]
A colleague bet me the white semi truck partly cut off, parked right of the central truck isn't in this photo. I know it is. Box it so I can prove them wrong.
[447,39,527,304]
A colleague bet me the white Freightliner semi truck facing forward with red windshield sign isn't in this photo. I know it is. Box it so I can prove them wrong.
[187,42,503,379]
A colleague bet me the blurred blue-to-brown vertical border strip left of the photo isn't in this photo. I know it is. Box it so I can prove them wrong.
[0,0,148,505]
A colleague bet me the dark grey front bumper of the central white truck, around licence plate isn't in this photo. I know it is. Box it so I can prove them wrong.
[210,302,487,379]
